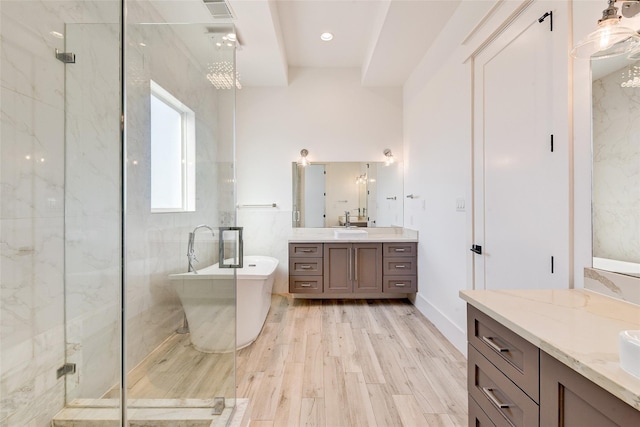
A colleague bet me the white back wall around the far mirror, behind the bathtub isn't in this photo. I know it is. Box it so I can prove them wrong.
[237,68,403,293]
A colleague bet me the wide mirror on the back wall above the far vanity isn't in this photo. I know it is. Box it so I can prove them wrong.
[292,162,404,228]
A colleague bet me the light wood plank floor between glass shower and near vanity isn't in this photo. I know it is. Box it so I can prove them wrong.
[237,295,467,427]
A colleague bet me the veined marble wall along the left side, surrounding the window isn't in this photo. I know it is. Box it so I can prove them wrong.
[0,0,235,427]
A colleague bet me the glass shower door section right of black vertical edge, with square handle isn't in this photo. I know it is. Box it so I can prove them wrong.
[124,1,236,420]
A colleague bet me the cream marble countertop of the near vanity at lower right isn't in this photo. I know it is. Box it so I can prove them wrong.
[460,289,640,410]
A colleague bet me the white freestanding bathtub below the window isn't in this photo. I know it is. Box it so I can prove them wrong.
[169,256,278,353]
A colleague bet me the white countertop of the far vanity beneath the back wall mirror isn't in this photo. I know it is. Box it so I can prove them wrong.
[289,227,418,243]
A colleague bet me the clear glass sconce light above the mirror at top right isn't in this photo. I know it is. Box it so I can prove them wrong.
[571,0,640,59]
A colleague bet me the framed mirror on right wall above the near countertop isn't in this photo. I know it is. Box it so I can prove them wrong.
[591,56,640,277]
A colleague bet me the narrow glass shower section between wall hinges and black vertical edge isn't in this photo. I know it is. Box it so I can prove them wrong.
[61,18,122,407]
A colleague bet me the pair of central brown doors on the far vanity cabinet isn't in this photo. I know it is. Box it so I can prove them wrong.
[324,243,382,294]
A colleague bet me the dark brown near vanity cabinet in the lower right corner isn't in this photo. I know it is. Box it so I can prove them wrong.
[467,305,640,427]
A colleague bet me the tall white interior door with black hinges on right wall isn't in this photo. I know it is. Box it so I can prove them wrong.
[474,4,569,289]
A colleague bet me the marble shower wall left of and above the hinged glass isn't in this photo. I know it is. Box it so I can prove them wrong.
[0,0,119,427]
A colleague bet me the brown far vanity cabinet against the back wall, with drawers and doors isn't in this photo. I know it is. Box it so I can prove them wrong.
[289,242,418,297]
